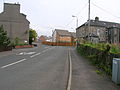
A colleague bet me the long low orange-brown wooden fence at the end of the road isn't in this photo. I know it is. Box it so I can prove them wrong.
[42,41,76,46]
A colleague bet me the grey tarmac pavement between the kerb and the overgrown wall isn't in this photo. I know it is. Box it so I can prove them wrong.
[71,48,120,90]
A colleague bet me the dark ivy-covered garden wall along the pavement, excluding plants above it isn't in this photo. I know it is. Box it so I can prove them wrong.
[77,44,120,75]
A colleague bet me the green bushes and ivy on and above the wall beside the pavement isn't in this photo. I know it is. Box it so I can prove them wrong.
[77,44,112,76]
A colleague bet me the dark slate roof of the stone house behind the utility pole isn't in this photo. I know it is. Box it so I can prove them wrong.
[77,20,120,29]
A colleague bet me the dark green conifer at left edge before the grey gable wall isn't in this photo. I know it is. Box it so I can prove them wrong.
[0,25,11,46]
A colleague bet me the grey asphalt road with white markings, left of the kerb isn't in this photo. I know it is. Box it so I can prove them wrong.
[0,45,69,90]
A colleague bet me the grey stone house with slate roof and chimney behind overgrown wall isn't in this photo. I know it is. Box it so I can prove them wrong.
[76,17,120,43]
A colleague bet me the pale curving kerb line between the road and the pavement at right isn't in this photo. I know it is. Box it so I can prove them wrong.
[67,50,72,90]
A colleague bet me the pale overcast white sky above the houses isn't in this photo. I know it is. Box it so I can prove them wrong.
[0,0,120,36]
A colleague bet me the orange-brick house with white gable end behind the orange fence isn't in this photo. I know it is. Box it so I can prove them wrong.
[52,29,72,42]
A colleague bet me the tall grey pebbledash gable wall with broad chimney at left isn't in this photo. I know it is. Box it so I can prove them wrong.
[0,3,30,43]
